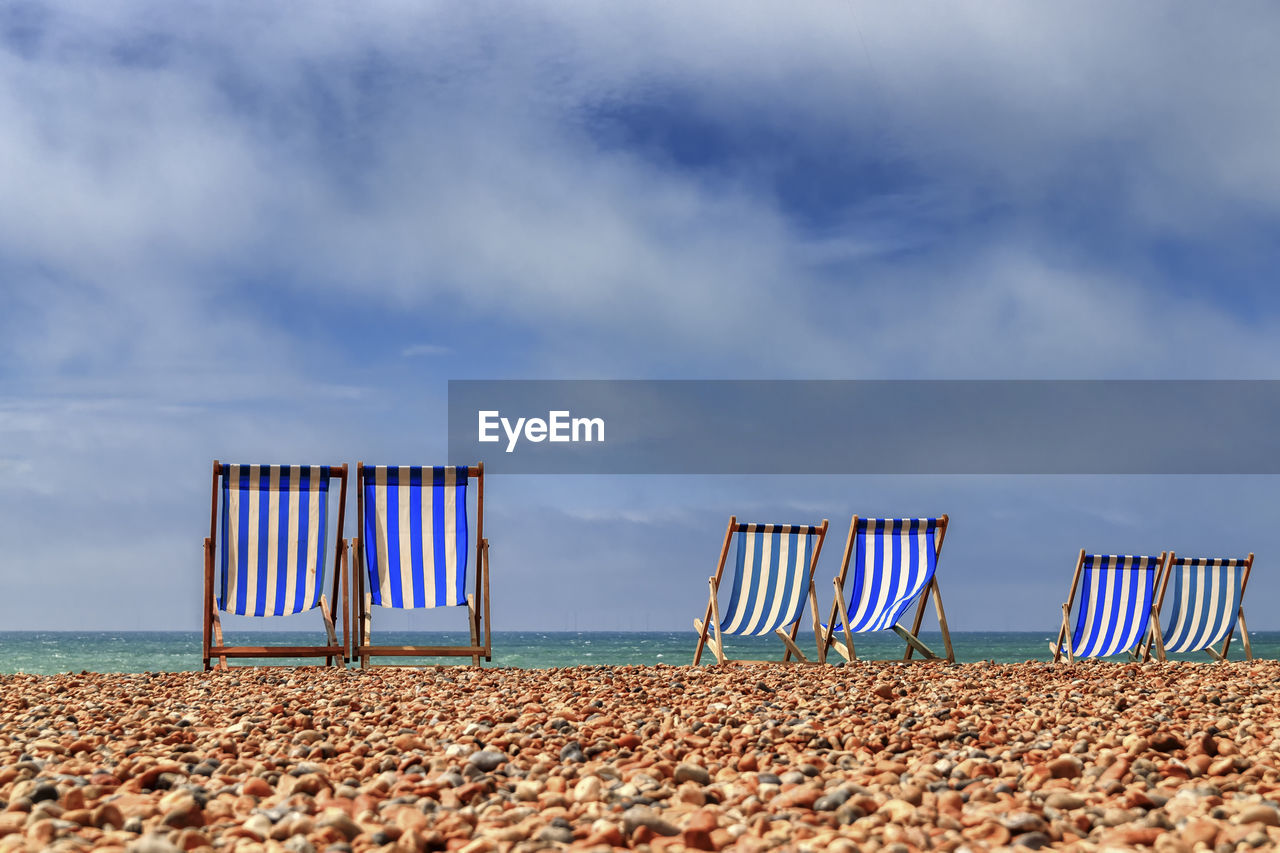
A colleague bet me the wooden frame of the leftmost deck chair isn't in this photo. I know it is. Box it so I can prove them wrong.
[201,460,349,671]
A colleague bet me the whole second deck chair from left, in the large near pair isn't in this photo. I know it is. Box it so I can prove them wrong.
[352,462,493,667]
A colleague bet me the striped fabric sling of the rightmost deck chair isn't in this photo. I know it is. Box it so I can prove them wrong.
[1161,556,1249,652]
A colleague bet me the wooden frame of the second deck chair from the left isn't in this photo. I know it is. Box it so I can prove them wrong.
[351,462,493,669]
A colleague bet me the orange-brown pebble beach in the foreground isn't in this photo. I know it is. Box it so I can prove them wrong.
[0,662,1280,853]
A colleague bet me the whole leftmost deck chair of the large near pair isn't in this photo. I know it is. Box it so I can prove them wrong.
[201,460,349,670]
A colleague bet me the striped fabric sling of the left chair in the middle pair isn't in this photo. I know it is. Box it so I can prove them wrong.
[721,524,822,637]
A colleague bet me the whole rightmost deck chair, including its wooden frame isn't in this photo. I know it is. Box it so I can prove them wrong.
[1143,552,1253,661]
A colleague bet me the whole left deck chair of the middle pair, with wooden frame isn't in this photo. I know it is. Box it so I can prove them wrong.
[694,516,827,666]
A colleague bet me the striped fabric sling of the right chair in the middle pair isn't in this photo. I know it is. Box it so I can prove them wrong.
[846,519,946,633]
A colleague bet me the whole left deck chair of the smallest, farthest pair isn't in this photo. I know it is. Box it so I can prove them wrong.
[1048,549,1165,663]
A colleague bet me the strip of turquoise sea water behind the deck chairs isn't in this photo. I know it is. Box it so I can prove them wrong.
[0,630,1280,674]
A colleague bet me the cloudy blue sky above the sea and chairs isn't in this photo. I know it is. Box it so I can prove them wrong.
[0,0,1280,634]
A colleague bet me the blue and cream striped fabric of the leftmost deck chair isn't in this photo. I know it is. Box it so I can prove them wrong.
[218,465,330,616]
